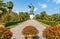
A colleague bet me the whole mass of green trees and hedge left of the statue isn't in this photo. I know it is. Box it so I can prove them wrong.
[0,0,29,27]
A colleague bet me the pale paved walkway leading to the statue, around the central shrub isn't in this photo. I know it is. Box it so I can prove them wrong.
[11,20,45,39]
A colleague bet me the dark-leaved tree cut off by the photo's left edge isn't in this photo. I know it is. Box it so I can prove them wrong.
[0,0,7,22]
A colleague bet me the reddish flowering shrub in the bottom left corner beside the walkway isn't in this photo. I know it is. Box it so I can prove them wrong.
[0,27,12,39]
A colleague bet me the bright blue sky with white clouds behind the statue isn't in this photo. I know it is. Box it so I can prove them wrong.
[4,0,60,14]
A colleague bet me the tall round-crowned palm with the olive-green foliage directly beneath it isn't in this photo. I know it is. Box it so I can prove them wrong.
[2,1,13,22]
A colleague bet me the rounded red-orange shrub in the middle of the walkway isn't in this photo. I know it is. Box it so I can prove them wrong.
[22,26,38,35]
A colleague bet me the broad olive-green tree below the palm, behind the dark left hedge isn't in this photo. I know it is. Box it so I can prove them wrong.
[5,12,19,22]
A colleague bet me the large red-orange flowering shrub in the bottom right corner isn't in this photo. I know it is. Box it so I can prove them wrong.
[43,26,60,39]
